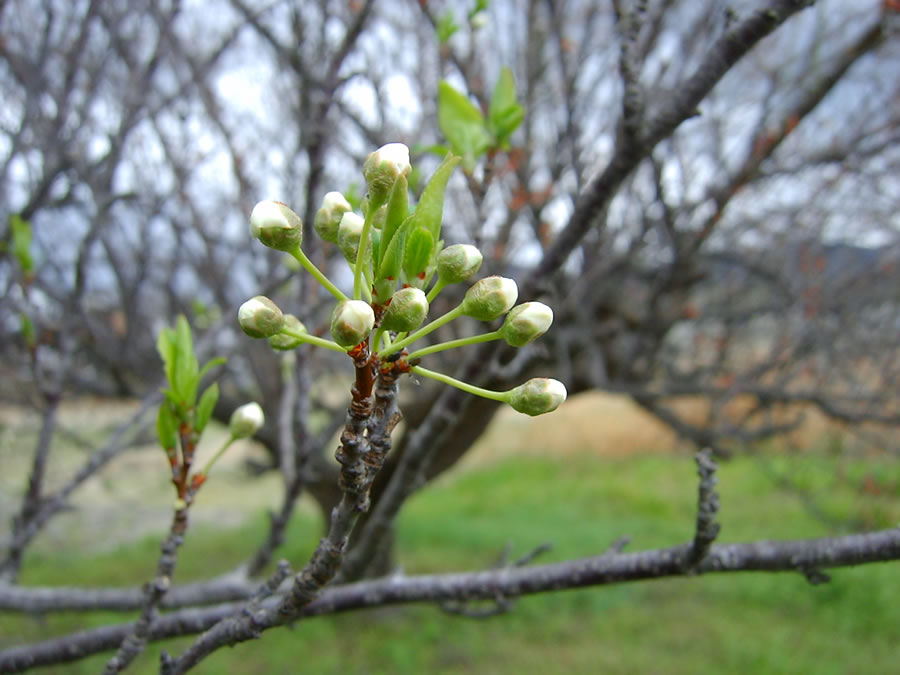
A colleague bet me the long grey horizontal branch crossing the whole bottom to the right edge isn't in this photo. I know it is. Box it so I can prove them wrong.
[0,528,900,673]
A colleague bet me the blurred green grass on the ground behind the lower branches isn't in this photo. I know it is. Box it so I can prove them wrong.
[0,448,900,675]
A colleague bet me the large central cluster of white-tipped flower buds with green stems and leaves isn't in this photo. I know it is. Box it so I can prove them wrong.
[238,143,566,415]
